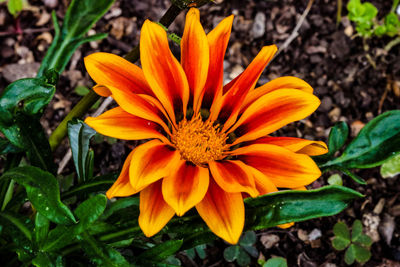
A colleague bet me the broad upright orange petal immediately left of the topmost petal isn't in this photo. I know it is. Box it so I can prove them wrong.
[140,20,189,121]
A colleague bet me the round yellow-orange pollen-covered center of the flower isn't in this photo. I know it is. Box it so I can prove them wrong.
[171,115,227,166]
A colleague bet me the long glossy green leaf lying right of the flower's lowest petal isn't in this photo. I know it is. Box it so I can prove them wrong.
[245,186,362,230]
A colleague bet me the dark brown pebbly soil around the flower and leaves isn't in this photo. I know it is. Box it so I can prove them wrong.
[0,0,400,267]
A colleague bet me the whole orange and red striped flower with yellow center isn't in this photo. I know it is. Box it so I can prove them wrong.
[85,8,327,244]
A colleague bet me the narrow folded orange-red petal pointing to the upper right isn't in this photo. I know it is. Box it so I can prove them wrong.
[210,45,277,131]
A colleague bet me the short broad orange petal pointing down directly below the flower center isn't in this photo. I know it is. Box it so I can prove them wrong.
[162,160,209,216]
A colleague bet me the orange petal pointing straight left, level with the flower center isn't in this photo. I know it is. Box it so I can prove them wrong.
[85,107,169,143]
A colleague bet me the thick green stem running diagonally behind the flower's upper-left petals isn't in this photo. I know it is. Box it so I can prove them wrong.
[49,5,182,151]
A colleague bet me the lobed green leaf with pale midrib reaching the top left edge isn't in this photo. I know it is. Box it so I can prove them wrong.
[38,0,114,77]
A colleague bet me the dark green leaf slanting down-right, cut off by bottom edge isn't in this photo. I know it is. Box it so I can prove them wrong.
[80,233,130,267]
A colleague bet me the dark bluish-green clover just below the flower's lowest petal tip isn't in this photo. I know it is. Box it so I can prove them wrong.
[224,231,258,266]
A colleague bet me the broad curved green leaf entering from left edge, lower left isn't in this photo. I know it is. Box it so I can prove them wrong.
[0,166,76,224]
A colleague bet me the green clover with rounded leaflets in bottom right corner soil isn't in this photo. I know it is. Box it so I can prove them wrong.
[332,220,372,265]
